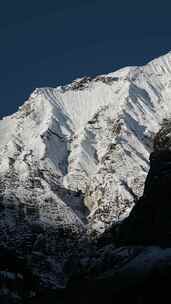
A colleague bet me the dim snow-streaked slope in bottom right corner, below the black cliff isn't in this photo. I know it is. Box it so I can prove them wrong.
[26,239,171,304]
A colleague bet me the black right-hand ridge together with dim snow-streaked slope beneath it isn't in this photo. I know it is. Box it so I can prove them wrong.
[63,149,171,303]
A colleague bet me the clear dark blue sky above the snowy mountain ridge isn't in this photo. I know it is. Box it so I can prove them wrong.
[0,0,171,117]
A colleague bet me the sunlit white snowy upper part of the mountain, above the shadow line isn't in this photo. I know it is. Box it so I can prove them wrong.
[0,53,171,229]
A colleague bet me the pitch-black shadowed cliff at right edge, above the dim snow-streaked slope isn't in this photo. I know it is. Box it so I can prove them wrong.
[114,150,171,247]
